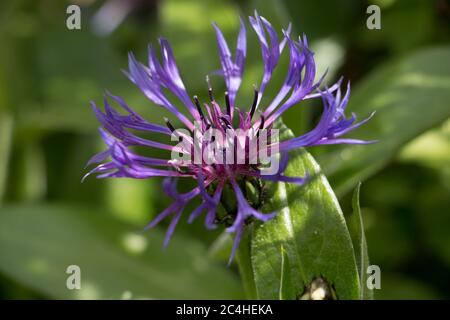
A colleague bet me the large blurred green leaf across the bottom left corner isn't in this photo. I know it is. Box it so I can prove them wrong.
[0,205,241,299]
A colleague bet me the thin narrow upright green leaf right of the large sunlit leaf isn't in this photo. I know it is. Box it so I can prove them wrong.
[347,183,373,300]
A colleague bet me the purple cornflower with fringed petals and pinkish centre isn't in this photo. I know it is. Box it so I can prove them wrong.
[85,13,370,262]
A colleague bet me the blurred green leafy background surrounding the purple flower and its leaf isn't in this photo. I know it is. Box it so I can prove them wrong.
[0,0,450,299]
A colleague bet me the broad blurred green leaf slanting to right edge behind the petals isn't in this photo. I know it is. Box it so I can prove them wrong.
[317,47,450,195]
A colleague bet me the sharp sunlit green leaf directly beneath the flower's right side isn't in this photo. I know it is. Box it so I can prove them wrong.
[251,120,360,299]
